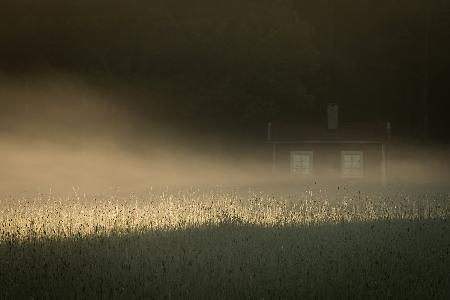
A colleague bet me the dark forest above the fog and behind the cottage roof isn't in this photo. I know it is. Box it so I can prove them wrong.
[0,0,450,138]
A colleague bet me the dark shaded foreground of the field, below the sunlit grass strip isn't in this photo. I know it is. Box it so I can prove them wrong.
[0,219,450,299]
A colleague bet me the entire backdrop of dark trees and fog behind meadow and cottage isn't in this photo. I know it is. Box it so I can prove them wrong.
[0,0,450,189]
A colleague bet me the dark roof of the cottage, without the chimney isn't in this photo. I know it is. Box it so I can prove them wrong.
[270,122,388,142]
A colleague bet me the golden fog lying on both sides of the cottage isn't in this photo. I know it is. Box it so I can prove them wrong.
[0,74,450,192]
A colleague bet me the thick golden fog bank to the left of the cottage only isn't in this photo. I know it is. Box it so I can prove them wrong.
[0,75,274,191]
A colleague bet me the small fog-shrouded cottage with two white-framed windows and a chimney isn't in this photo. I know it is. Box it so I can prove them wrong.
[267,104,390,185]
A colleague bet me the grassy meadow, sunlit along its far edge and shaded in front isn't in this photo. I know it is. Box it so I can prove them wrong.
[0,187,450,299]
